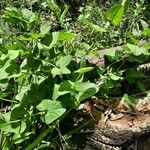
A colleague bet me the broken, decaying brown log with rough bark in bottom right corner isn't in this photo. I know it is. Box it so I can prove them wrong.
[70,94,150,150]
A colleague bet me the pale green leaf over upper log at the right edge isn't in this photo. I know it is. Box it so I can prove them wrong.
[127,43,148,56]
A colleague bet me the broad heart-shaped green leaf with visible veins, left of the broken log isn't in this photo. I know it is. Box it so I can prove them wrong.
[37,99,66,124]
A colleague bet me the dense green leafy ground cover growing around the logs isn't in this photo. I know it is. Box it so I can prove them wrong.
[0,0,150,150]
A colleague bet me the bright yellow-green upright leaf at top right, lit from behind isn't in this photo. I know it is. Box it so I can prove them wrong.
[106,5,124,25]
